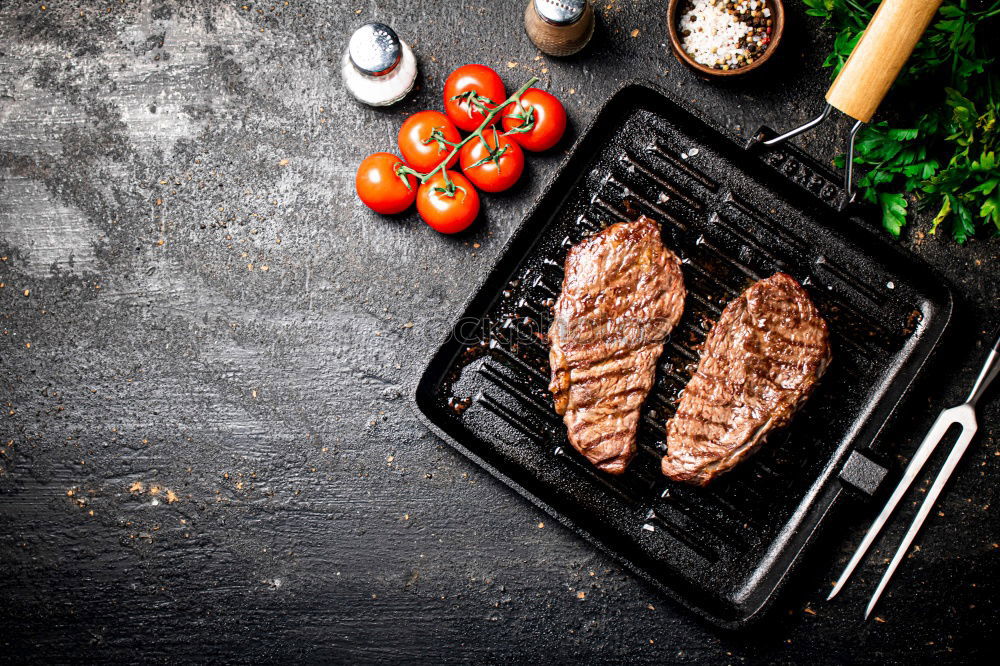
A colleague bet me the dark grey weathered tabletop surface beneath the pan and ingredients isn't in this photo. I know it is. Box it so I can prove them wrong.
[0,0,1000,663]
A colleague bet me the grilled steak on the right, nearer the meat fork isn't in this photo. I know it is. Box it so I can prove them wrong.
[663,273,830,486]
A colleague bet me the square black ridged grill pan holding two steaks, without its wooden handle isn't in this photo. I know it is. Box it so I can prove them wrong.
[415,83,952,627]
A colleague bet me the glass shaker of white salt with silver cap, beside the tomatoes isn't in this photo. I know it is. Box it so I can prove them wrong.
[340,23,417,106]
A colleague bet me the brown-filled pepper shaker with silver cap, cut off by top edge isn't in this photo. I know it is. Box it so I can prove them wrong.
[524,0,594,56]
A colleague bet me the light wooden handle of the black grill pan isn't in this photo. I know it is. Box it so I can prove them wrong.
[826,0,942,123]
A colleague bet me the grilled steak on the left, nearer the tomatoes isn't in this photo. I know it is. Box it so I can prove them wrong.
[549,217,685,474]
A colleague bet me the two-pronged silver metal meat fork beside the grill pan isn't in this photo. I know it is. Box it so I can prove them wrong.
[826,329,1000,619]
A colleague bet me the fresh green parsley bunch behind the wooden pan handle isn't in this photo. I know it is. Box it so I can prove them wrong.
[804,0,1000,243]
